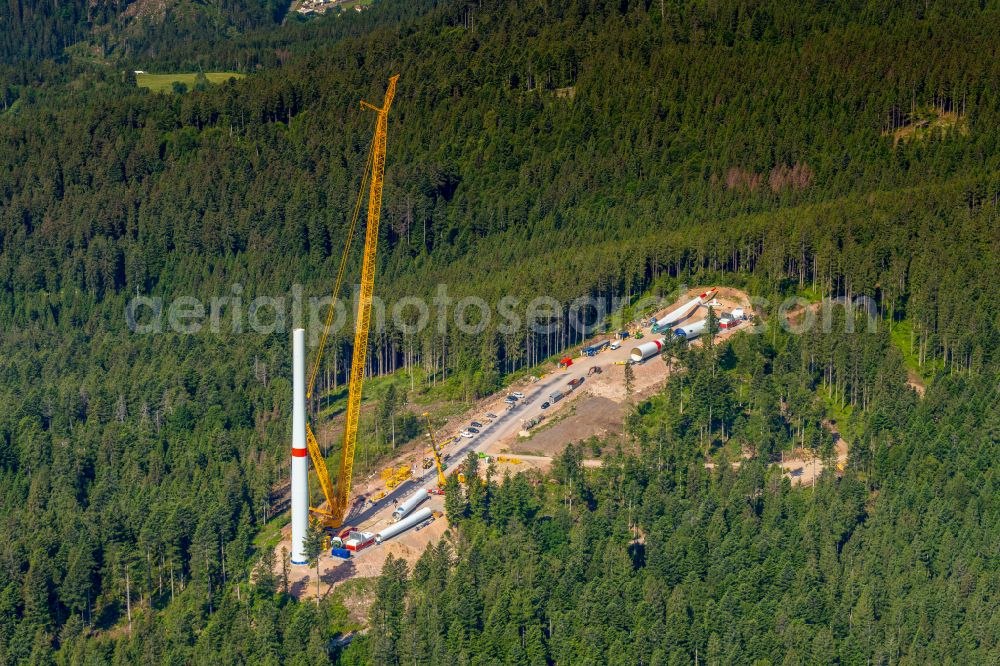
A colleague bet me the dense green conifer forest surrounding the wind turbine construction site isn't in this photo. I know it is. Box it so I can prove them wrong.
[0,0,1000,664]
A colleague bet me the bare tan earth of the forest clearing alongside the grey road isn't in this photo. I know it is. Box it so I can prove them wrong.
[274,286,754,598]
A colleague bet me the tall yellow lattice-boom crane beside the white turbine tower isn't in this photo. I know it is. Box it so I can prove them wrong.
[306,75,399,531]
